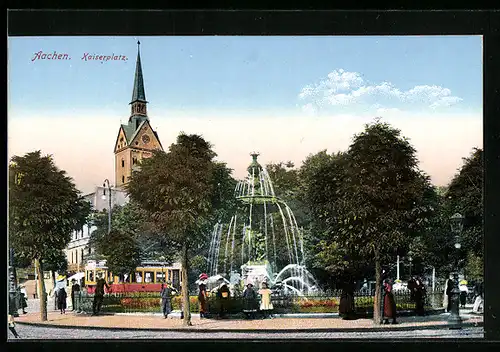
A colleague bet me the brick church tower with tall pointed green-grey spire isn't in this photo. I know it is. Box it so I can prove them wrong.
[115,42,163,187]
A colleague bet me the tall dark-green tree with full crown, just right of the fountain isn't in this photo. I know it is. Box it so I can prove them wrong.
[309,120,432,323]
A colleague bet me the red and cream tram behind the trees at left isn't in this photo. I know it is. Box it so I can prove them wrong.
[84,260,181,293]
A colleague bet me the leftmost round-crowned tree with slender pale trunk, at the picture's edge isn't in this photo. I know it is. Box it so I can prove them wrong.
[9,151,88,321]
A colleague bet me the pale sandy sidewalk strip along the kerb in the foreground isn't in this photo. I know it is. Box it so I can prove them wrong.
[16,311,483,333]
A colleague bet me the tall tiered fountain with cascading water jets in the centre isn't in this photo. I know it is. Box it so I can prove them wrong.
[208,153,318,295]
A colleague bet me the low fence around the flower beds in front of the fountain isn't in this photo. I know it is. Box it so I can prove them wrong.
[80,290,443,314]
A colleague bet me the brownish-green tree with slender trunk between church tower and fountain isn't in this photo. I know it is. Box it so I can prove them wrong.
[127,133,234,325]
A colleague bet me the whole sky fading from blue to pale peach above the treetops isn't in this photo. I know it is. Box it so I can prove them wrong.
[8,36,483,193]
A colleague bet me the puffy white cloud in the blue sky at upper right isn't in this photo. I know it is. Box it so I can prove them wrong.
[298,69,462,111]
